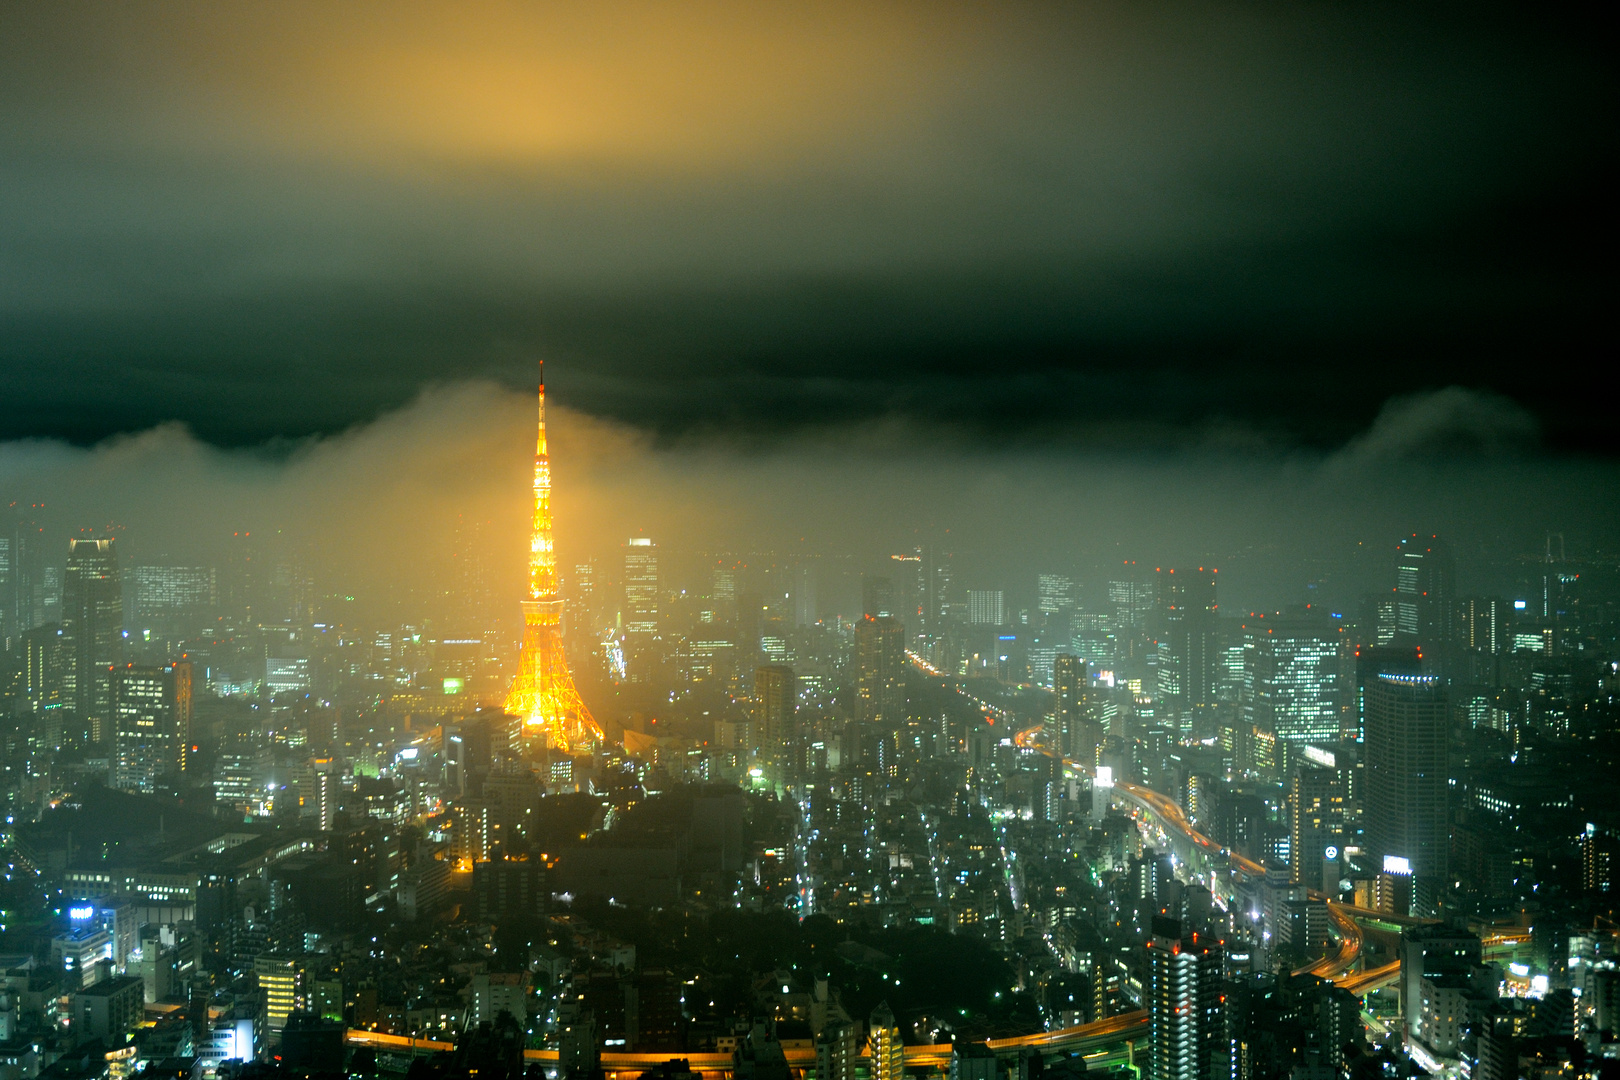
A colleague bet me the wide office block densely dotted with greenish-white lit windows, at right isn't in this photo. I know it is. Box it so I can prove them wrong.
[1243,615,1346,743]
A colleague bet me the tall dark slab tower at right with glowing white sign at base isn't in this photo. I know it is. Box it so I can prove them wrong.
[1362,674,1450,892]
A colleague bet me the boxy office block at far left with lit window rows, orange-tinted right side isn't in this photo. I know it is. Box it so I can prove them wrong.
[112,661,191,792]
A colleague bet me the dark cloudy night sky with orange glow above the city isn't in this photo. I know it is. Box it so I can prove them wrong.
[0,3,1620,612]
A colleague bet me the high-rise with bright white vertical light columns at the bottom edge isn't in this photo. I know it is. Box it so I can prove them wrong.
[1147,918,1231,1080]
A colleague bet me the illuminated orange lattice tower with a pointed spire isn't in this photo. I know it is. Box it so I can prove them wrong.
[505,361,603,751]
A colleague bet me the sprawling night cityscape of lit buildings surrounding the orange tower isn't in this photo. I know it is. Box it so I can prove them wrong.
[0,463,1620,1080]
